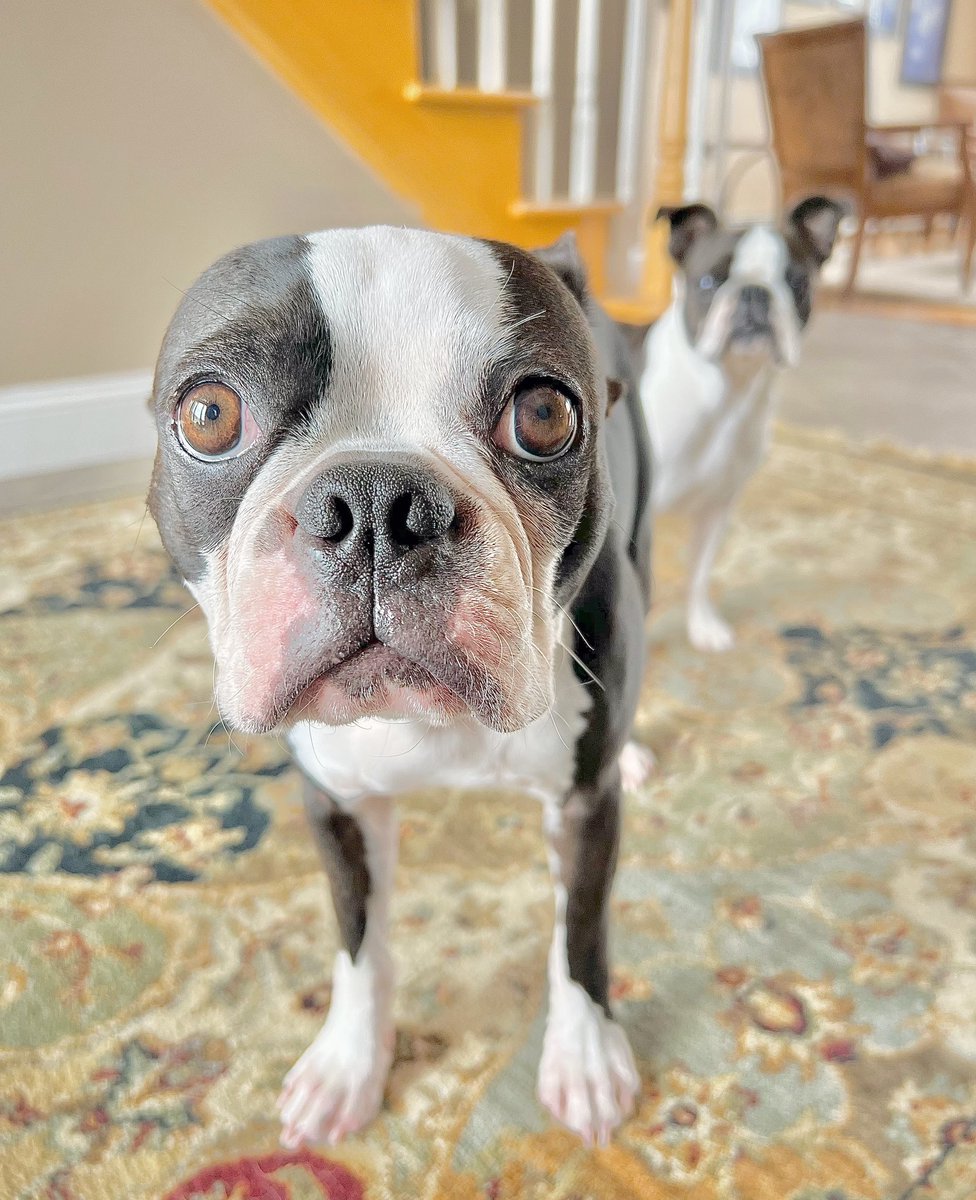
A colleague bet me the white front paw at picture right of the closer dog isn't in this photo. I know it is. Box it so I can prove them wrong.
[538,983,640,1146]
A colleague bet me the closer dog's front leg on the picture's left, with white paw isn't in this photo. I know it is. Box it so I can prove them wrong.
[279,784,397,1150]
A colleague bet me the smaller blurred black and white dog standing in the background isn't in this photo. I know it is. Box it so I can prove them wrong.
[640,196,846,650]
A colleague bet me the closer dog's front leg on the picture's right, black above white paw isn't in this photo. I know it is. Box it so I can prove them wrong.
[539,769,640,1145]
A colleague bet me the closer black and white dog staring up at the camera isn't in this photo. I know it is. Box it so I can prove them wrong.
[150,228,651,1147]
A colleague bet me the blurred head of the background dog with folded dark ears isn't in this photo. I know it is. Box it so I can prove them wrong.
[659,196,845,365]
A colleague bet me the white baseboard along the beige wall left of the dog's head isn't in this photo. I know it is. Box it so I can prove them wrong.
[0,371,156,480]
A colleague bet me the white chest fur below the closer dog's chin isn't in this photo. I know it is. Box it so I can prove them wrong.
[288,649,592,804]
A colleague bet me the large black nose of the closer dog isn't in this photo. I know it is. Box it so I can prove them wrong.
[295,458,455,558]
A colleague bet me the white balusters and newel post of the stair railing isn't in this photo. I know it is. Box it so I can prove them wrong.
[419,0,669,295]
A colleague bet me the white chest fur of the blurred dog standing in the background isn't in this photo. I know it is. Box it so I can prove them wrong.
[640,304,773,512]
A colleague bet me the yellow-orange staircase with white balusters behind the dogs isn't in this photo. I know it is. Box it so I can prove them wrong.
[208,0,691,323]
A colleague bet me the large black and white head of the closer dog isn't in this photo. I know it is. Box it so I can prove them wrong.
[150,228,611,731]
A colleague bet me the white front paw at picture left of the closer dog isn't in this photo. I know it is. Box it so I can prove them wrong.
[277,1020,394,1150]
